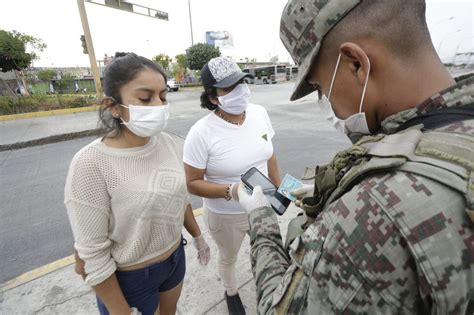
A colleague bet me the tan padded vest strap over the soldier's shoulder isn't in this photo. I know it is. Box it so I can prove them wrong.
[334,128,474,222]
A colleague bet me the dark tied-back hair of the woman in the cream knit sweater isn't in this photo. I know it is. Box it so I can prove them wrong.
[99,53,166,137]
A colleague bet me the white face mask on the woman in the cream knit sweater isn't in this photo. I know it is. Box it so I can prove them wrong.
[121,105,170,138]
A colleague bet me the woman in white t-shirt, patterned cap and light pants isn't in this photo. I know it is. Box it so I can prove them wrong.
[183,57,280,314]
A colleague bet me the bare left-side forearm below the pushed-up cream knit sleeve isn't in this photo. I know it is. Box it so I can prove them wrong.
[93,273,131,315]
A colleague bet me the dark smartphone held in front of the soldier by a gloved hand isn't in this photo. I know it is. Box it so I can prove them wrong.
[242,167,291,215]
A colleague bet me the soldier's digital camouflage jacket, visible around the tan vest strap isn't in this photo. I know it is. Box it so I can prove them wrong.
[249,76,474,314]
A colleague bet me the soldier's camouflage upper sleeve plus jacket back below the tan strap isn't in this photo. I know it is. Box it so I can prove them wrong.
[302,172,472,314]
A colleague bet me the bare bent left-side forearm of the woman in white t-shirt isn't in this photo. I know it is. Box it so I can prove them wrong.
[184,163,231,199]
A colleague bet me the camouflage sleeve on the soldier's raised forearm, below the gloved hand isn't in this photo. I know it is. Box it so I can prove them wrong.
[249,207,289,314]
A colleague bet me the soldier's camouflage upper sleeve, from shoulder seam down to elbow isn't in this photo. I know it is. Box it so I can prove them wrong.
[308,174,421,314]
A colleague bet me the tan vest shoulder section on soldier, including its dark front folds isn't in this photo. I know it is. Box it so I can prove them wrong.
[302,119,474,222]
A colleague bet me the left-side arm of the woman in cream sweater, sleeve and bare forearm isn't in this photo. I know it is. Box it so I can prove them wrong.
[64,157,131,315]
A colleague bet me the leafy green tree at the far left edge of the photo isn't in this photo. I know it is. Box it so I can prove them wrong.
[0,30,46,94]
